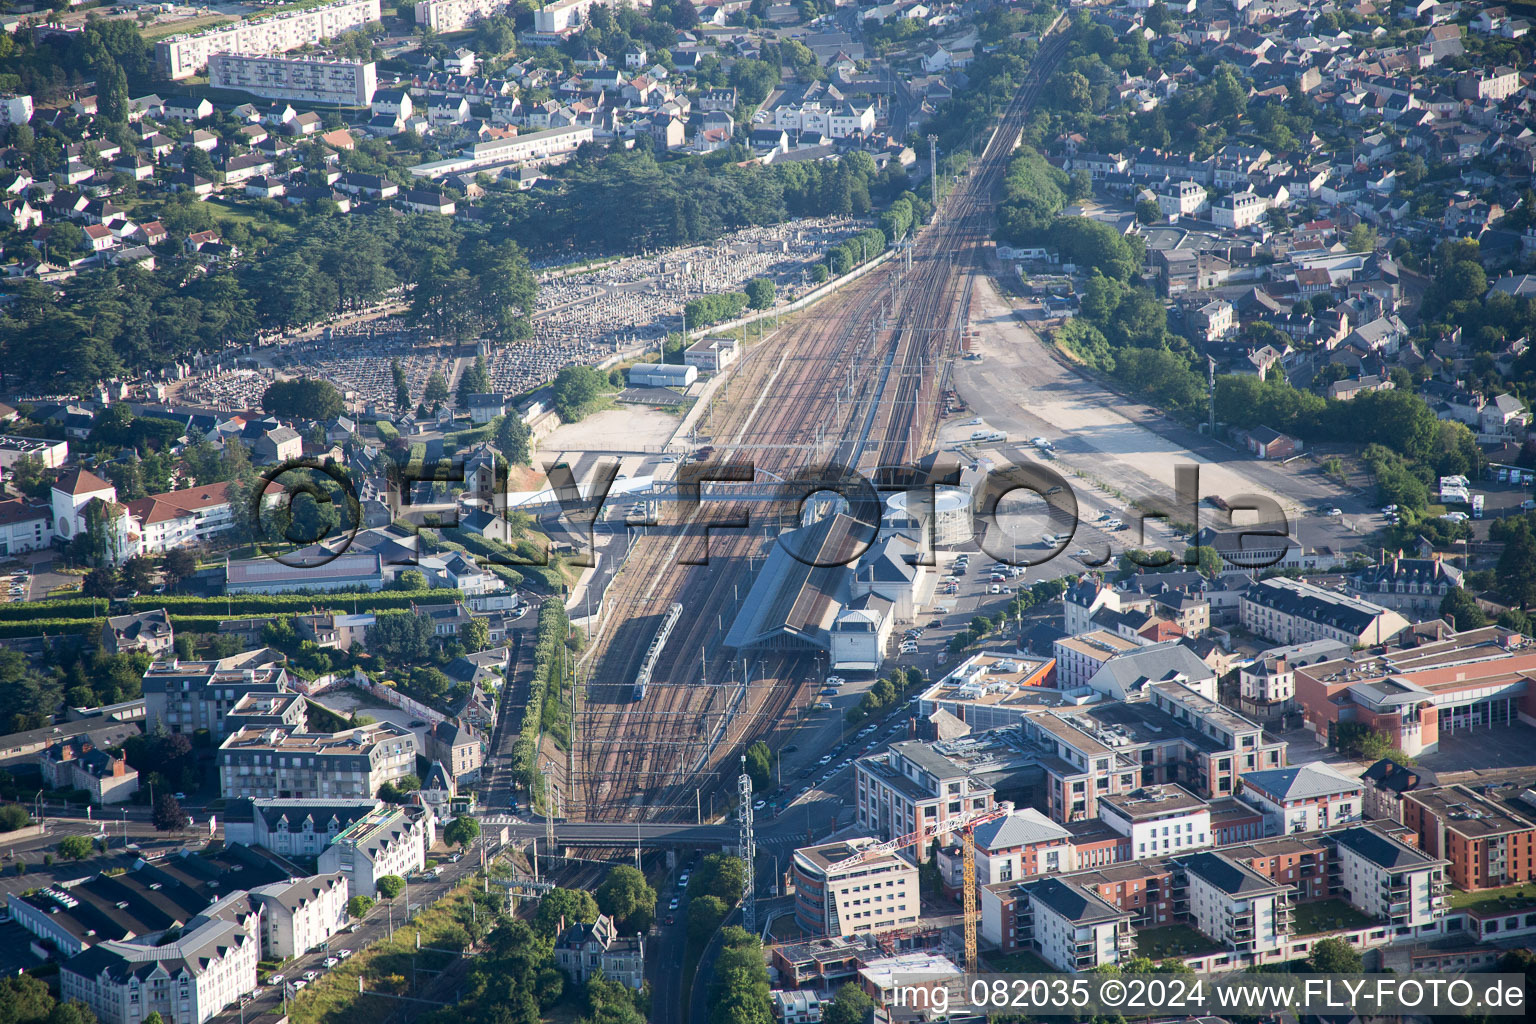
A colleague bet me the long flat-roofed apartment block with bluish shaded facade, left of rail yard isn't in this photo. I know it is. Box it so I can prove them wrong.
[218,722,416,800]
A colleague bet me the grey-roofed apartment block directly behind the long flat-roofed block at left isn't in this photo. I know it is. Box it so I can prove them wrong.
[143,648,290,740]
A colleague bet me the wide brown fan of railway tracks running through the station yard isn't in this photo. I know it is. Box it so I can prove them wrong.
[561,23,1066,821]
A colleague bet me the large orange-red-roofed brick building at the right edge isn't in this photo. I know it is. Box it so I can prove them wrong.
[1296,626,1536,757]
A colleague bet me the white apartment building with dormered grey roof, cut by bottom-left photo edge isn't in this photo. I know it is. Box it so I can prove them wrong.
[58,918,261,1024]
